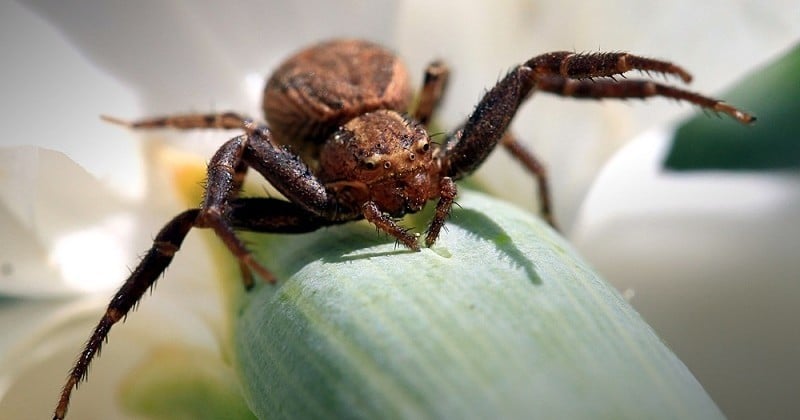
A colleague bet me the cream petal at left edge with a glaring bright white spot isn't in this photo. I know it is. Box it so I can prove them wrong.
[0,147,134,296]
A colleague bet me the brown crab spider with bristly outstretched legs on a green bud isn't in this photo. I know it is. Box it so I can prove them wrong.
[54,40,755,419]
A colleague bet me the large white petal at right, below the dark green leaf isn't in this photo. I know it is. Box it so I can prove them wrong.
[572,131,800,418]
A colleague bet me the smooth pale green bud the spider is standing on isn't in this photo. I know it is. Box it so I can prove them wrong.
[235,191,722,419]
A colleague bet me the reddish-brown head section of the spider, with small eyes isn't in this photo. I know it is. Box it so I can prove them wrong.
[320,110,439,215]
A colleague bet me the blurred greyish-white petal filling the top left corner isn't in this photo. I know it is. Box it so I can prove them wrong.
[0,2,144,197]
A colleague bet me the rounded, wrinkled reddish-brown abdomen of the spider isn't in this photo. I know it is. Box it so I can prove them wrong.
[263,40,411,156]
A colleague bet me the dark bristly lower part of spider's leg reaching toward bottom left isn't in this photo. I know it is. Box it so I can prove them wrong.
[53,209,200,419]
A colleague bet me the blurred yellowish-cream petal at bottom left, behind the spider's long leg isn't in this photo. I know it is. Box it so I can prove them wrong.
[0,293,222,419]
